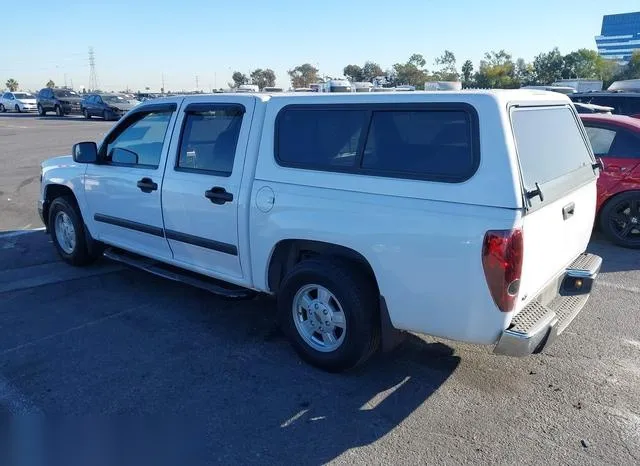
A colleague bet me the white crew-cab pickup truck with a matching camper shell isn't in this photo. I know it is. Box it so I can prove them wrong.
[39,90,601,371]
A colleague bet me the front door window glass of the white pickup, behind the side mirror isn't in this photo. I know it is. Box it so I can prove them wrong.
[101,112,172,168]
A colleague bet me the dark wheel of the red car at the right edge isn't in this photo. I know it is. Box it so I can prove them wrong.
[600,191,640,249]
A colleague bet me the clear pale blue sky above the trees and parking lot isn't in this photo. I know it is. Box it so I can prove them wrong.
[0,0,640,92]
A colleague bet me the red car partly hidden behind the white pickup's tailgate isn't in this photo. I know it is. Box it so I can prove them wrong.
[580,114,640,248]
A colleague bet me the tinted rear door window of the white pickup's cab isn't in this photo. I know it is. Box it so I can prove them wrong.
[176,105,244,176]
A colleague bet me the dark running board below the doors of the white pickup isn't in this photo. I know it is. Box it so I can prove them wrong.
[103,248,256,299]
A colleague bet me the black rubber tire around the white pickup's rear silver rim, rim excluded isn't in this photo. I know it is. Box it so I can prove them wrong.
[278,259,380,372]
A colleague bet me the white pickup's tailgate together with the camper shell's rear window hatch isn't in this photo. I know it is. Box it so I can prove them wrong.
[511,105,598,311]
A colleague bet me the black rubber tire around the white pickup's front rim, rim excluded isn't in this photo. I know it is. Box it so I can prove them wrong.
[49,196,102,266]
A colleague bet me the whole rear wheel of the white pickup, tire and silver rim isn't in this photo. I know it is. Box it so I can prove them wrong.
[278,259,380,372]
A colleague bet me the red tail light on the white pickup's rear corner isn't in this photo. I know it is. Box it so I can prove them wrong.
[482,229,524,312]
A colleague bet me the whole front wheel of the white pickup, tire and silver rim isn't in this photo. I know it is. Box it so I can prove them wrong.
[49,196,100,266]
